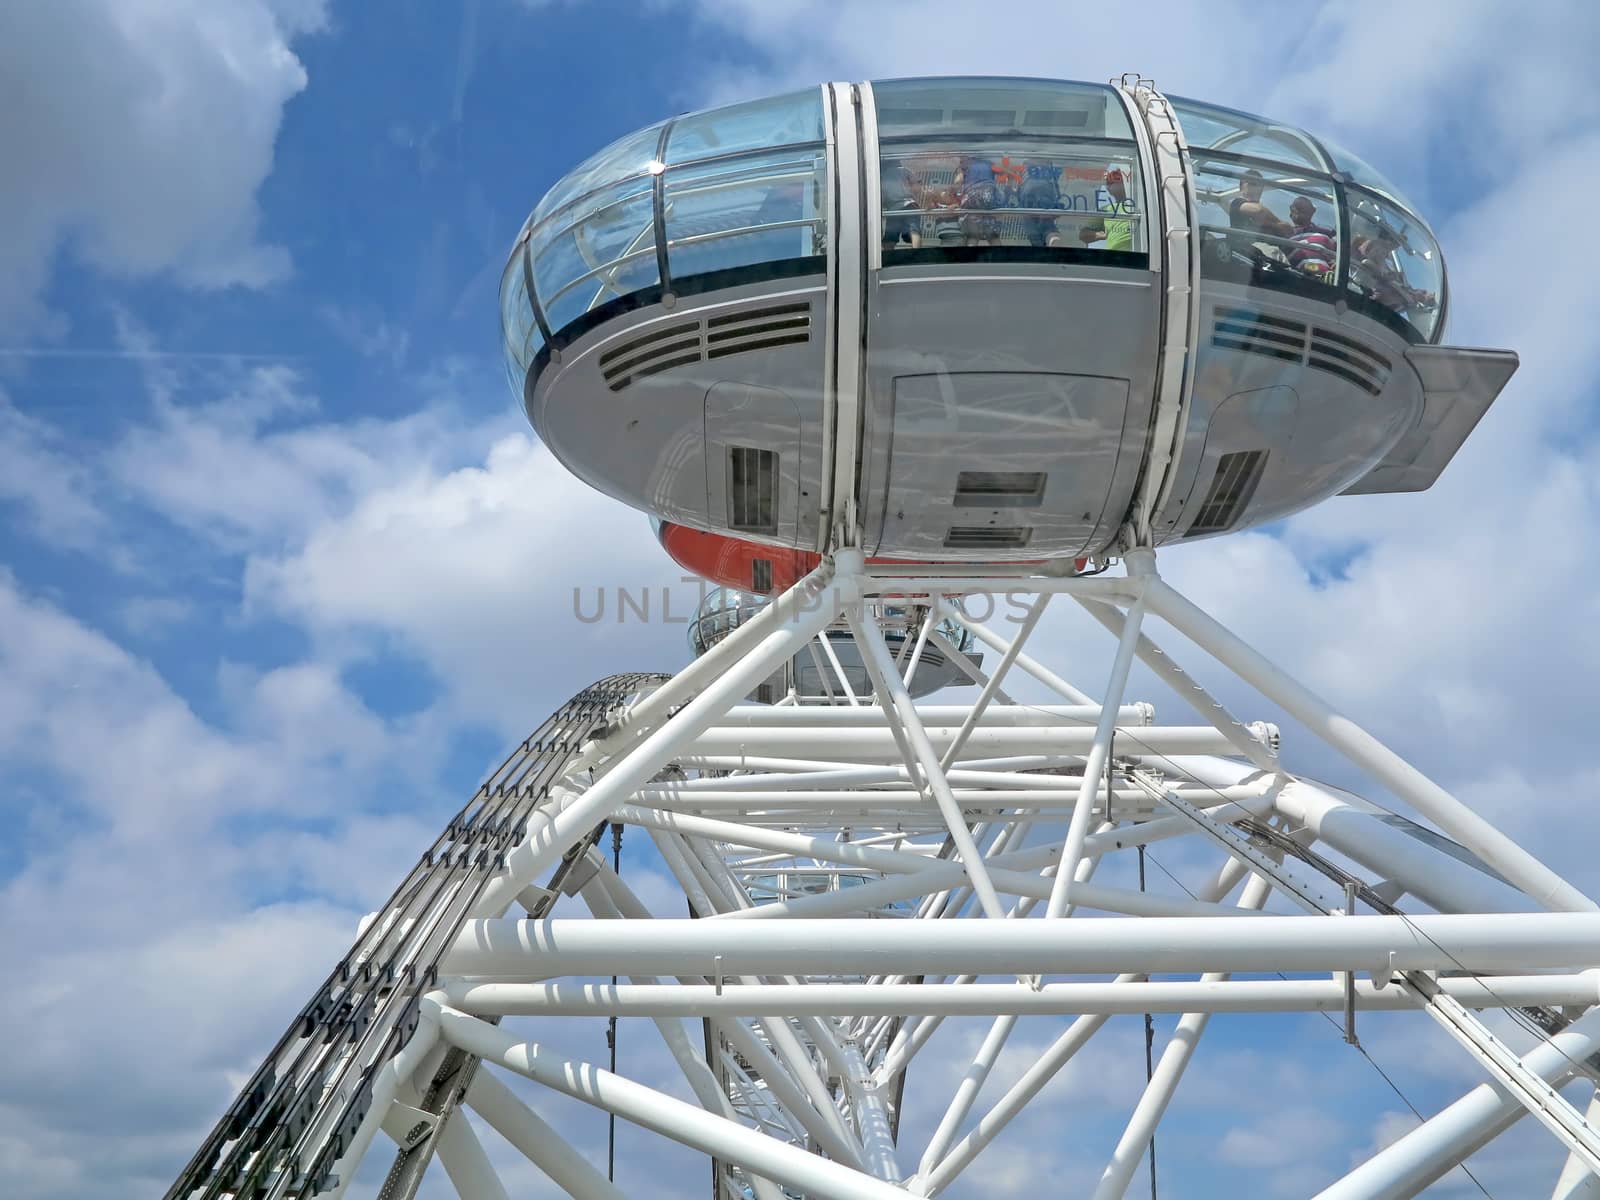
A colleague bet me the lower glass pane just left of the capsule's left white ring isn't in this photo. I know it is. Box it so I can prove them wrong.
[664,146,827,278]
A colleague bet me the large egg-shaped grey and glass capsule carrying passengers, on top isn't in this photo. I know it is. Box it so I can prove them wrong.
[501,78,1517,563]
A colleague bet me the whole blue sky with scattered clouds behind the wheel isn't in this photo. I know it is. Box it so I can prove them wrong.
[0,0,1600,1198]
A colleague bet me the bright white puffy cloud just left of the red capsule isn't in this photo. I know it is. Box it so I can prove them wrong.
[245,434,694,733]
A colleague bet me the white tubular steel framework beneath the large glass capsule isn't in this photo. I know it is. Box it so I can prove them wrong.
[259,550,1600,1200]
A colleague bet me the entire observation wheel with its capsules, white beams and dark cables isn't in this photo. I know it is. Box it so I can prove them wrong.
[166,77,1600,1200]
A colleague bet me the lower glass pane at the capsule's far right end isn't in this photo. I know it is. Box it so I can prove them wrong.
[1346,187,1445,341]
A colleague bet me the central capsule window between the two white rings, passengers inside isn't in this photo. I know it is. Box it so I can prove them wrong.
[872,78,1149,262]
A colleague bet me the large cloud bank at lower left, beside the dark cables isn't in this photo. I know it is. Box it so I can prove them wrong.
[0,578,422,1197]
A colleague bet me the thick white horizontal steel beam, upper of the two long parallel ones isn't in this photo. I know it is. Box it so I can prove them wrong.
[442,912,1600,978]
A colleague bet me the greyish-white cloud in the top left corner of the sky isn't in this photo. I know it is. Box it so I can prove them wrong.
[0,0,325,331]
